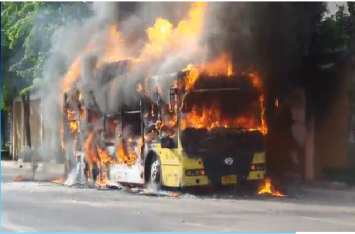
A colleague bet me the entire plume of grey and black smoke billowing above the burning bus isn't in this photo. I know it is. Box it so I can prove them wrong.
[34,2,330,165]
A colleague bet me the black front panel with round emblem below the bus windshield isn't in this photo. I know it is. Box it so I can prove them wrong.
[181,129,264,184]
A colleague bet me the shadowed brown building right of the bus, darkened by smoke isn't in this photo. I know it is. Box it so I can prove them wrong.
[266,51,355,182]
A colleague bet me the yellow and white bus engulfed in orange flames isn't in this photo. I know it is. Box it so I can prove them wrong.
[63,59,266,188]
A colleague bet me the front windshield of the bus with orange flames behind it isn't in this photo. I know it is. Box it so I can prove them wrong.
[181,88,261,130]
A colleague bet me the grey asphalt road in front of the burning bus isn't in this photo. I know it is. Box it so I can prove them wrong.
[1,169,355,232]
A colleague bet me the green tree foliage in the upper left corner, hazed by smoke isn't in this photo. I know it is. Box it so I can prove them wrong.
[1,2,90,110]
